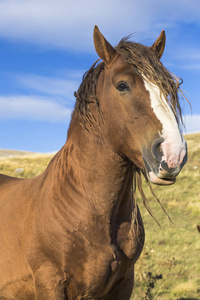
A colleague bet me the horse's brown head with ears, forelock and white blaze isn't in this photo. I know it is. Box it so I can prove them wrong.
[94,26,187,184]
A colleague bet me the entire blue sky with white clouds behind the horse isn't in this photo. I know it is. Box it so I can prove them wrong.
[0,0,200,152]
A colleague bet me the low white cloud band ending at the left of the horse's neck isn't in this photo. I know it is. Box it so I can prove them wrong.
[0,95,72,122]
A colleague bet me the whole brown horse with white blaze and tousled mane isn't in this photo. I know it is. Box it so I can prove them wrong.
[0,27,187,300]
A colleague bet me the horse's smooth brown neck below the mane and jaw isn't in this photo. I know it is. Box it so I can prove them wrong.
[47,115,133,227]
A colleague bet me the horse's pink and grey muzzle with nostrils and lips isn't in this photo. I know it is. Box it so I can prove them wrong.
[143,138,187,185]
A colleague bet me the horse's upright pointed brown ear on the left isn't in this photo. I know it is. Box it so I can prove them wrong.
[93,25,117,65]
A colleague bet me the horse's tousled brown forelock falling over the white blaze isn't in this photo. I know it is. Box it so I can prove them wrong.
[116,38,187,122]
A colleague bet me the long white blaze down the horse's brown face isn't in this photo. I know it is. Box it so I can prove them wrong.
[144,78,186,168]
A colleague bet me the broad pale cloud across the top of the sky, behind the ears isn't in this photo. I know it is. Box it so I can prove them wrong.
[0,0,200,51]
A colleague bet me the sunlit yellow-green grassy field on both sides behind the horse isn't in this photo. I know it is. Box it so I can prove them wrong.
[0,134,200,300]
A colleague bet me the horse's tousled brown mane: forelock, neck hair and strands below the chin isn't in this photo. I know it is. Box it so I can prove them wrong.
[74,38,187,223]
